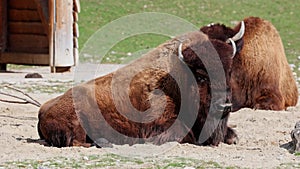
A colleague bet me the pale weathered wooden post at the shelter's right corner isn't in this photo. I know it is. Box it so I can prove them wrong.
[49,0,75,73]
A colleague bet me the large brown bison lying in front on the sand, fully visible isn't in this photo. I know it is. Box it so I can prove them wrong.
[38,30,242,147]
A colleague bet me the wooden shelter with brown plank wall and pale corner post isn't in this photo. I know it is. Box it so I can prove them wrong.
[0,0,80,72]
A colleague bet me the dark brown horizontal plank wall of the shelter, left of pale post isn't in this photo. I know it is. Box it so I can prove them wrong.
[7,0,49,54]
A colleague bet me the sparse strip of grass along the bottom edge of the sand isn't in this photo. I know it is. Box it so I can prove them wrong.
[0,154,239,169]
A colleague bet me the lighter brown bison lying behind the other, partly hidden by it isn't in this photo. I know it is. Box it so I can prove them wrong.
[200,17,298,111]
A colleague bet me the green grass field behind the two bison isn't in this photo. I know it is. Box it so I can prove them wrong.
[79,0,300,65]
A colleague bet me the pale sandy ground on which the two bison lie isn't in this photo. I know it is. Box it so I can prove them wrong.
[0,65,300,168]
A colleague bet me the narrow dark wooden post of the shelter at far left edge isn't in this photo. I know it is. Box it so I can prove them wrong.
[0,0,7,71]
